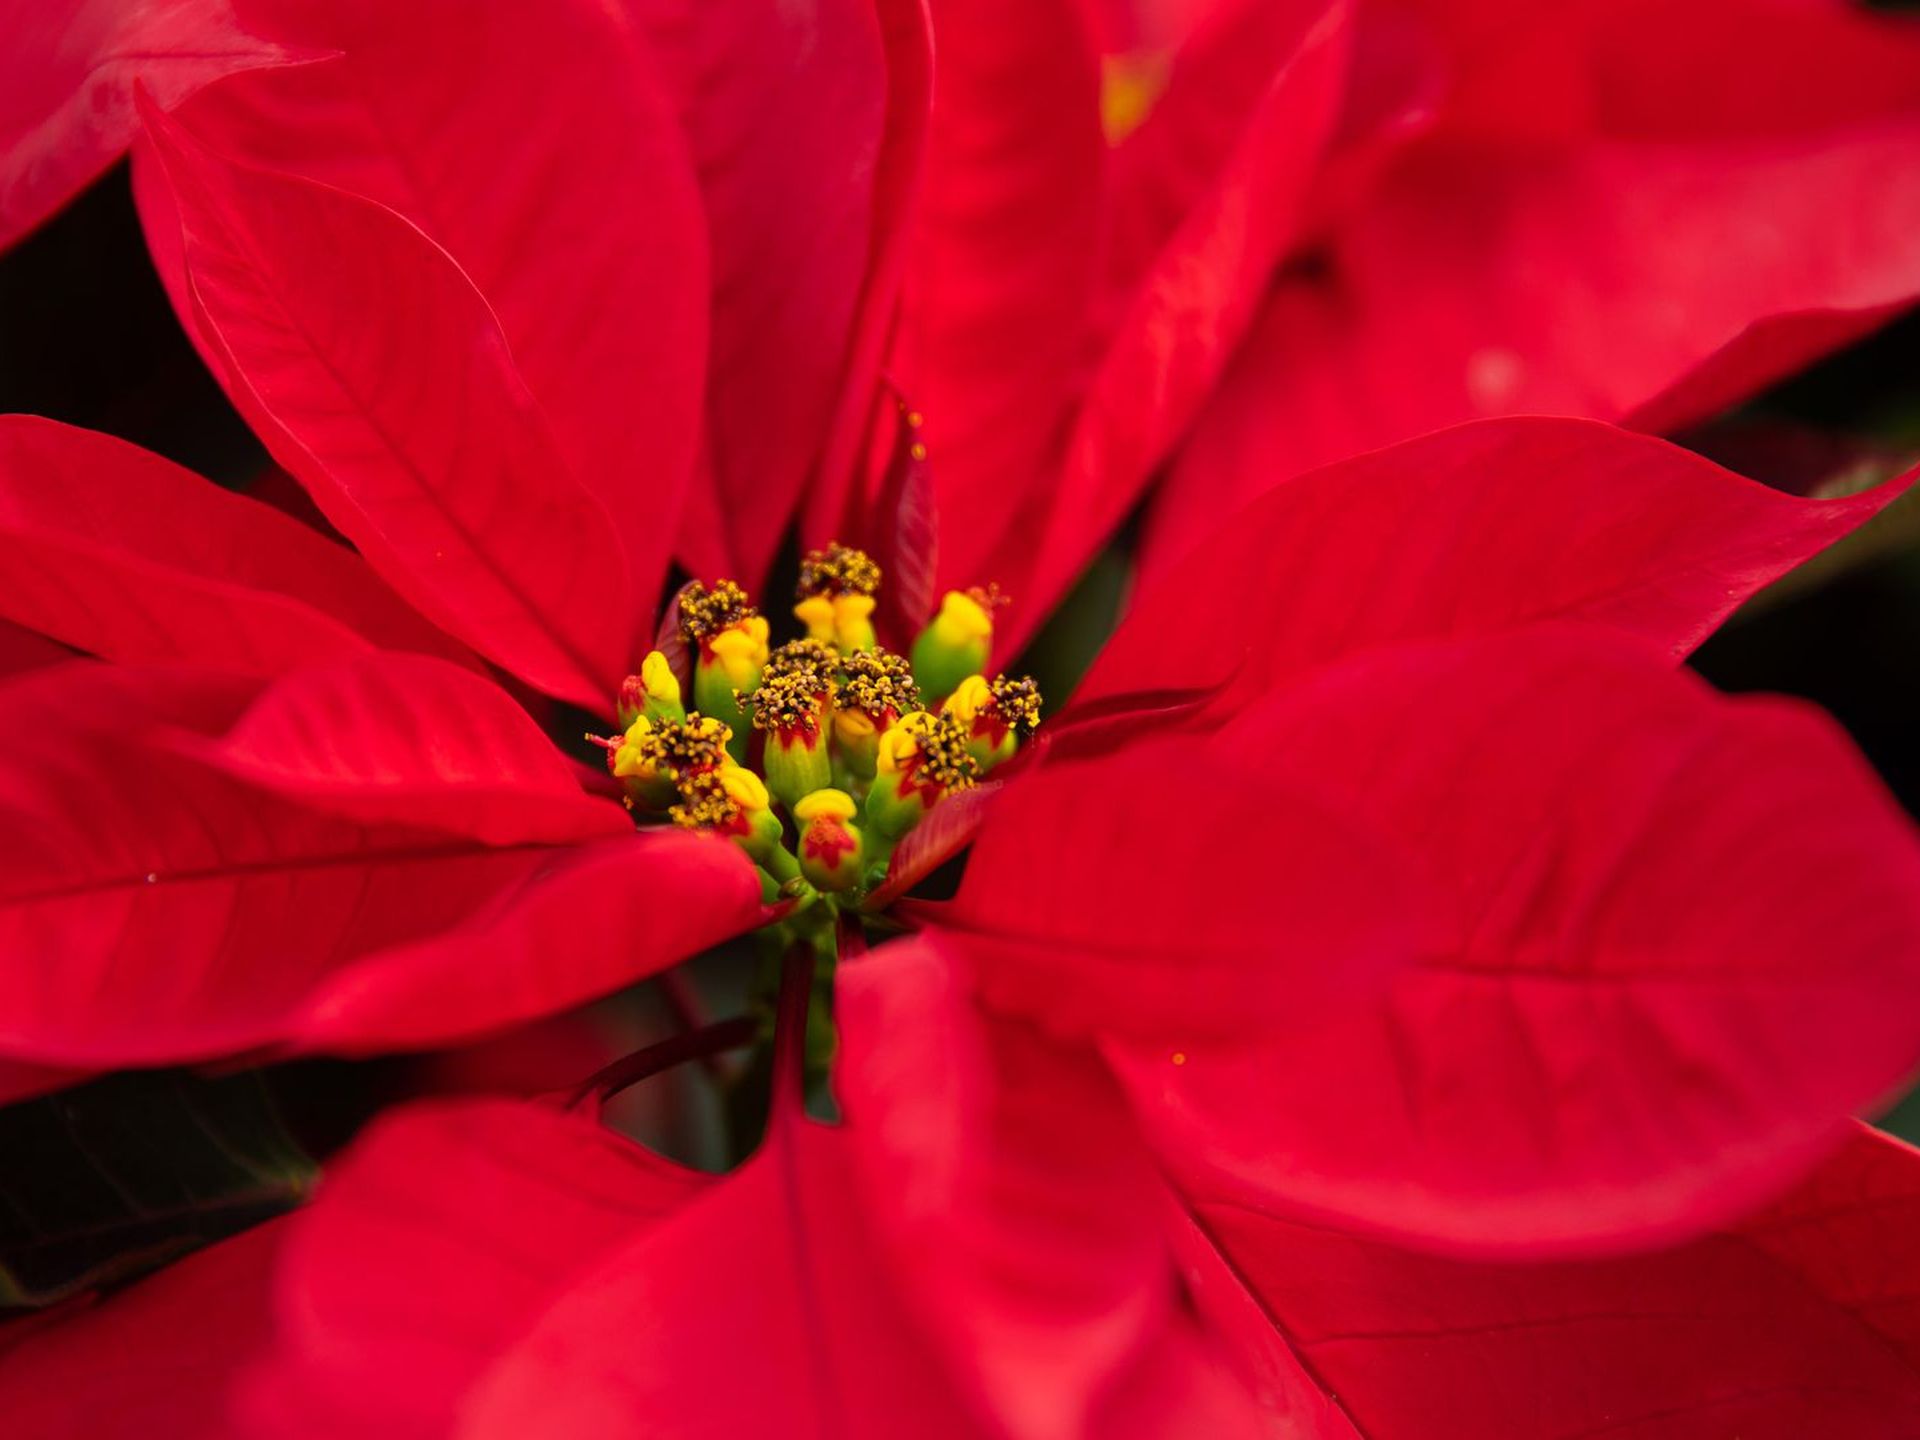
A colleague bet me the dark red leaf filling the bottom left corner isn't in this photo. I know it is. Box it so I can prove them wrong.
[0,1219,290,1440]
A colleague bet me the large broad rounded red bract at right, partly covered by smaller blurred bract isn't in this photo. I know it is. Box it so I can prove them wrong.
[1113,630,1920,1254]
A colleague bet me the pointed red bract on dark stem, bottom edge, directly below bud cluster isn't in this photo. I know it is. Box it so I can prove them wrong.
[461,1121,979,1440]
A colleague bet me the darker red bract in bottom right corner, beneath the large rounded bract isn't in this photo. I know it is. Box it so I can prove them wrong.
[1190,1131,1920,1440]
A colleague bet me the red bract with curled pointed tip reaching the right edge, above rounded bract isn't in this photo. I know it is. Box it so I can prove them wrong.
[1068,419,1910,716]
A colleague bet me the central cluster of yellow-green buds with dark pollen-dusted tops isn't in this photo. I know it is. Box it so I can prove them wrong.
[591,543,1041,900]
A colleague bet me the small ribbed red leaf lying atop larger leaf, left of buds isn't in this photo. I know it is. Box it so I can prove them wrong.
[205,655,634,845]
